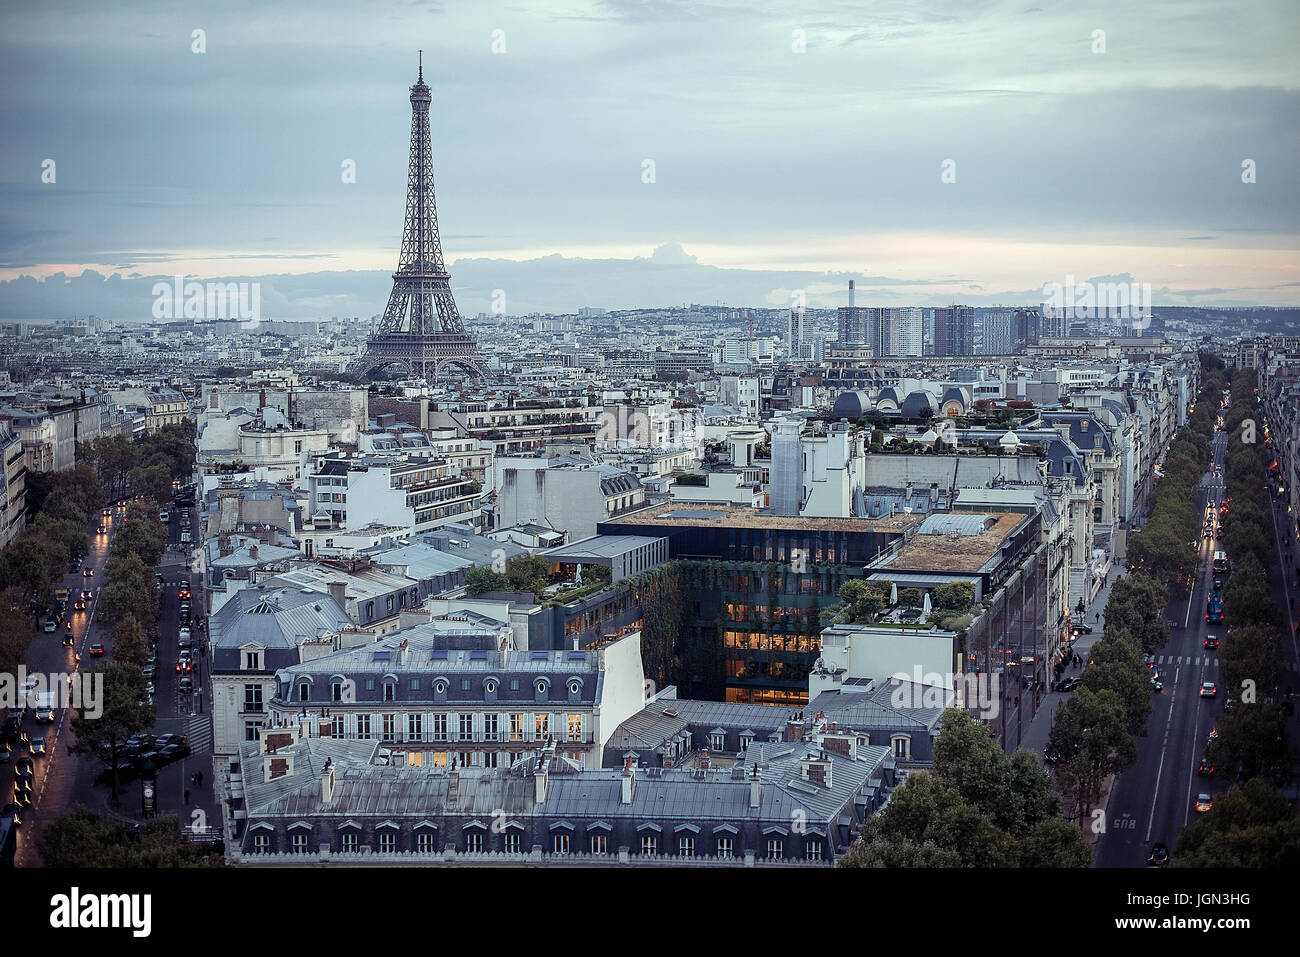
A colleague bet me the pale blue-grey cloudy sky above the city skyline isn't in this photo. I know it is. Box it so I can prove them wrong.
[0,0,1300,319]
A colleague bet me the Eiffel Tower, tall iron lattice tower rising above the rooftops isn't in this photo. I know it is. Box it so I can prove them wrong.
[348,51,486,382]
